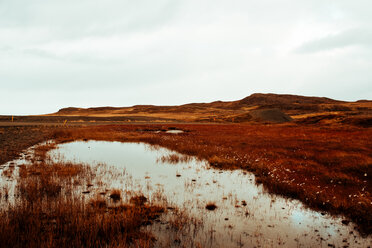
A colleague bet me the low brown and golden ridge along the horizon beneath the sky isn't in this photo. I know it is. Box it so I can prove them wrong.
[47,93,372,126]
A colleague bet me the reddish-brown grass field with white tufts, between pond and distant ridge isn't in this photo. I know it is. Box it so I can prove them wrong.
[51,124,372,233]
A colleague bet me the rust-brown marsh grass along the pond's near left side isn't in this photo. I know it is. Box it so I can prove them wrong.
[0,144,163,247]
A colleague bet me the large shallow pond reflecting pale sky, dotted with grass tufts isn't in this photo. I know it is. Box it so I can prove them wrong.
[45,141,372,247]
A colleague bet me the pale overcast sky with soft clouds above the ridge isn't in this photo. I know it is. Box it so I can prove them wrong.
[0,0,372,114]
